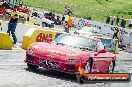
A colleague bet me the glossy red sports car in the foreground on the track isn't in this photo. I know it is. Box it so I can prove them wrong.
[25,34,116,78]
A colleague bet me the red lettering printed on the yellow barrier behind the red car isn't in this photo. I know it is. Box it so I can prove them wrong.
[36,33,52,43]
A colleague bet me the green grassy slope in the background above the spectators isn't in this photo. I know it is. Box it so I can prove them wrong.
[23,0,132,22]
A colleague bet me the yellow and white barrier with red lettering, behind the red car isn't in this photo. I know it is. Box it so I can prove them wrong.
[22,28,63,49]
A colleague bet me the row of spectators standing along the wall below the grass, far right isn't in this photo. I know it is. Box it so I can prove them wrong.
[106,14,132,29]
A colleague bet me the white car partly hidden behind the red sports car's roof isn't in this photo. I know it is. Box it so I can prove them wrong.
[74,26,102,36]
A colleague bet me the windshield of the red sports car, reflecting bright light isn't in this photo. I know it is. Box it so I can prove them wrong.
[55,35,96,49]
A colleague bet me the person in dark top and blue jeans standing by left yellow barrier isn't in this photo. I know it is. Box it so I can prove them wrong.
[7,14,18,44]
